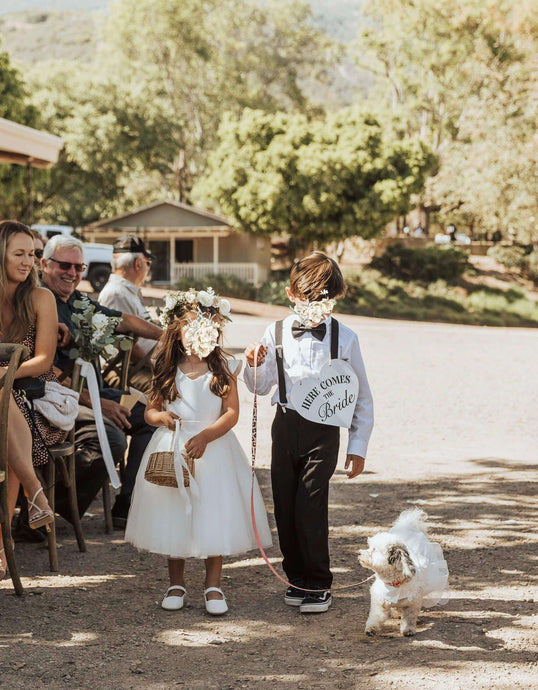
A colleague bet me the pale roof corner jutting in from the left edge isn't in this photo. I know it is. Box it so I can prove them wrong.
[0,117,64,168]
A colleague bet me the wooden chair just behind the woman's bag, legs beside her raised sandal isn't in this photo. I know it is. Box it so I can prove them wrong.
[44,363,86,572]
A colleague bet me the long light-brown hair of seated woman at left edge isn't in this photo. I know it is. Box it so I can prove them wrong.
[0,220,38,343]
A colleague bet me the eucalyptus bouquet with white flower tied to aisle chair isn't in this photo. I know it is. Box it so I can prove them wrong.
[69,295,130,362]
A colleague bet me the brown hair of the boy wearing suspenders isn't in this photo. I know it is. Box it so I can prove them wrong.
[290,252,346,302]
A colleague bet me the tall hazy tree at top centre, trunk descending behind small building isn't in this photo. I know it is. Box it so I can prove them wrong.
[100,0,334,200]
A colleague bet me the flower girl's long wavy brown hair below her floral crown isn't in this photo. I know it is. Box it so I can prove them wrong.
[149,304,232,407]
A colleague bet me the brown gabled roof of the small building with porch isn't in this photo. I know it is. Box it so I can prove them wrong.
[87,199,232,230]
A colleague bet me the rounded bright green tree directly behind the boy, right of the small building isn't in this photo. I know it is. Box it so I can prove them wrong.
[195,109,434,244]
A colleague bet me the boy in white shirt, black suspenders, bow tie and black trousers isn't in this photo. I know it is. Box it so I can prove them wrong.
[245,252,373,613]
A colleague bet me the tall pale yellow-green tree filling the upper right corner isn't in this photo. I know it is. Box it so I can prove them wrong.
[357,0,538,239]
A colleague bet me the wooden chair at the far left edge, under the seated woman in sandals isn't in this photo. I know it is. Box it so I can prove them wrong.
[0,343,28,596]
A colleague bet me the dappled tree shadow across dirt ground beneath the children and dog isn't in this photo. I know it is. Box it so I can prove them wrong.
[0,459,536,688]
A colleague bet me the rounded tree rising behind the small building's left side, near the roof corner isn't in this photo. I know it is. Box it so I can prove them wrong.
[29,63,175,226]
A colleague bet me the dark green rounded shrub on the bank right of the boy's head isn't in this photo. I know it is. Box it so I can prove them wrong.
[370,244,469,283]
